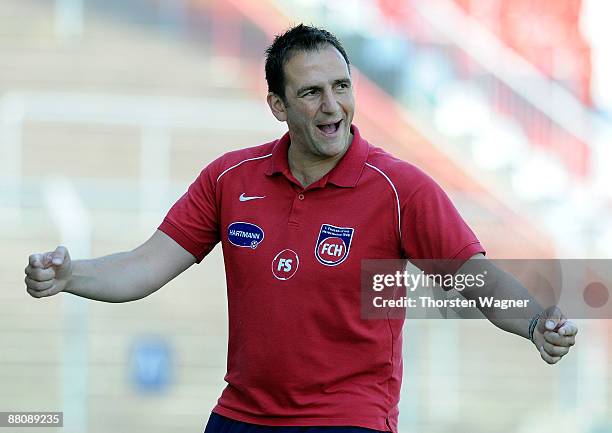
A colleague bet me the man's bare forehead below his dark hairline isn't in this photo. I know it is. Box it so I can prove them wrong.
[284,45,350,88]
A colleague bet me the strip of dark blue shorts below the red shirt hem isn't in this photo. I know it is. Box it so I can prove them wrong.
[204,412,383,433]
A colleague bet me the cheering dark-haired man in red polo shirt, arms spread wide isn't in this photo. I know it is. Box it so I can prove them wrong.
[26,25,577,432]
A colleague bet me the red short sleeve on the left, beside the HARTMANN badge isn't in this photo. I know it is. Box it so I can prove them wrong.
[158,164,220,263]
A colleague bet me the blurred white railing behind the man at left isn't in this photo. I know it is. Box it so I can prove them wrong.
[0,92,282,210]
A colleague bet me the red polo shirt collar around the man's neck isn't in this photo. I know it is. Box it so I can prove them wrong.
[266,125,369,188]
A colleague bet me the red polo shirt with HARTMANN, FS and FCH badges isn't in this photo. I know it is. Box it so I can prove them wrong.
[159,126,484,431]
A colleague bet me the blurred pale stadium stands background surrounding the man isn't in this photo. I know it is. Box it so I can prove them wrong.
[0,0,612,433]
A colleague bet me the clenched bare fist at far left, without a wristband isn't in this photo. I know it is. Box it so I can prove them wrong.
[25,246,72,298]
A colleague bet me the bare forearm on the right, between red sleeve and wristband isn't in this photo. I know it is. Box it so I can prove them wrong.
[461,260,543,338]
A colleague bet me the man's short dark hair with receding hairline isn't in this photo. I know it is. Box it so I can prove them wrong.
[266,24,351,100]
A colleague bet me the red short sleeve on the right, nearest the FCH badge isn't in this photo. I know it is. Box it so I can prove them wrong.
[401,175,485,263]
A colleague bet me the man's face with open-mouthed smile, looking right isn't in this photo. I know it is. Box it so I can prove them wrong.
[273,45,355,160]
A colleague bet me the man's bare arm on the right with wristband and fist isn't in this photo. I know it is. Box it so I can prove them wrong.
[457,254,578,364]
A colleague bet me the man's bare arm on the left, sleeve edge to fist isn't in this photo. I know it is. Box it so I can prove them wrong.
[25,230,196,302]
